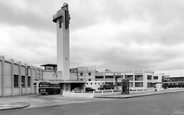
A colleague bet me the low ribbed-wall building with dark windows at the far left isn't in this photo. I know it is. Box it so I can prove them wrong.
[0,56,43,96]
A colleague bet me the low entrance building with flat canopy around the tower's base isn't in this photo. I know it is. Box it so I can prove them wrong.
[41,64,85,92]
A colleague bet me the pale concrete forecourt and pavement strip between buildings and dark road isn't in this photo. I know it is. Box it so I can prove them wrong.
[0,88,184,111]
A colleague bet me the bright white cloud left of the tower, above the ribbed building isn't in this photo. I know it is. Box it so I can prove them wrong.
[0,24,56,66]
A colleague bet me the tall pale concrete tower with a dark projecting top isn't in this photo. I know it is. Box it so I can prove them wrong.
[53,3,70,80]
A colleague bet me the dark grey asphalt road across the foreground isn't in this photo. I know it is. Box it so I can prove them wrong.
[0,92,184,115]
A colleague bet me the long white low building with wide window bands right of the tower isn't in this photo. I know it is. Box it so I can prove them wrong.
[79,70,165,90]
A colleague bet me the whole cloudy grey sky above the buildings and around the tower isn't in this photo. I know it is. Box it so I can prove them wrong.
[0,0,184,76]
